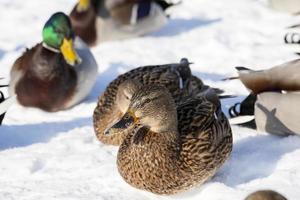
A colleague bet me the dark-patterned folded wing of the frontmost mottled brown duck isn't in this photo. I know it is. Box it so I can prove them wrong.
[177,97,232,172]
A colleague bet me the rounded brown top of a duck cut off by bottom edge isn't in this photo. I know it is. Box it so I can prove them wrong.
[245,190,287,200]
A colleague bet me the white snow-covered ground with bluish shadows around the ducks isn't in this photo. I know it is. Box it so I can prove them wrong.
[0,0,300,200]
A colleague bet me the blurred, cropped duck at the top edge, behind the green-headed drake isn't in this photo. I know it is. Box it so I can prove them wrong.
[70,0,173,46]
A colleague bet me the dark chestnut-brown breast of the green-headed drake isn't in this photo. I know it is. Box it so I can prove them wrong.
[11,43,77,111]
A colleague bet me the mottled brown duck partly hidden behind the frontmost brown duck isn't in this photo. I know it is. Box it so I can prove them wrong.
[93,59,209,145]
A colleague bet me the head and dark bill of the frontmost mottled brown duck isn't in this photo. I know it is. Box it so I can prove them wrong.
[105,85,177,134]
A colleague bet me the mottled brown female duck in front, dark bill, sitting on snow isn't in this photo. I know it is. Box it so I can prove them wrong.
[106,85,232,195]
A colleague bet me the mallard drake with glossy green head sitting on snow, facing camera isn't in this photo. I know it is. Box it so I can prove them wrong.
[9,12,98,112]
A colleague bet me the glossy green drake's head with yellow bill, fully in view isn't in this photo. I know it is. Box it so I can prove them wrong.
[43,12,80,66]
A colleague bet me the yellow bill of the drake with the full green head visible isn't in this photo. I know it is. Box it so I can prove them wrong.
[60,38,81,66]
